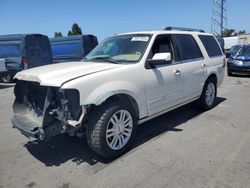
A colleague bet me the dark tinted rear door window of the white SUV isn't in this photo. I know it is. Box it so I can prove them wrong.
[172,34,203,61]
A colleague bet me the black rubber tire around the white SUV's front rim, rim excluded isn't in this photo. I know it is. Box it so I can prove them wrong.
[86,101,137,158]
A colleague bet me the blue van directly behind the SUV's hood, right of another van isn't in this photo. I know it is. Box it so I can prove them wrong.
[50,35,98,63]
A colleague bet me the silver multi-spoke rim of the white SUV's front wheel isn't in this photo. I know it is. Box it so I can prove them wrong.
[106,110,133,150]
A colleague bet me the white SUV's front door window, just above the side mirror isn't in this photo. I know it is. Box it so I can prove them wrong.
[148,35,173,59]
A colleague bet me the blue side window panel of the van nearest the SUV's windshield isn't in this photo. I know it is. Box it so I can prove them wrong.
[51,43,82,55]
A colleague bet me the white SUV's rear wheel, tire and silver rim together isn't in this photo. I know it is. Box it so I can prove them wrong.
[198,78,217,110]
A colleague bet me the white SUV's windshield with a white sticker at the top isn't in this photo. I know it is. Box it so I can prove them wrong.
[85,34,151,62]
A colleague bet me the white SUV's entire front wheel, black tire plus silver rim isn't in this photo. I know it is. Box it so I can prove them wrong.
[86,101,137,158]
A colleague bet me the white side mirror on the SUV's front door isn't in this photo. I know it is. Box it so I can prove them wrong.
[147,52,172,68]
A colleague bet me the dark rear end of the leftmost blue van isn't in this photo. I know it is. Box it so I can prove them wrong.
[24,34,52,68]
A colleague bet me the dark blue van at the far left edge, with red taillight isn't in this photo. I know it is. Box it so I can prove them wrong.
[0,34,52,82]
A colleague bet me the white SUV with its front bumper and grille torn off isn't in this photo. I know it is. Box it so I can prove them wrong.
[12,28,225,158]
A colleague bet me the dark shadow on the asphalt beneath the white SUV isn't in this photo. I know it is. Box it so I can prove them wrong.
[24,98,226,166]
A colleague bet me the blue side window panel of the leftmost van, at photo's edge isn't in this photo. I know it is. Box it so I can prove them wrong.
[0,44,21,58]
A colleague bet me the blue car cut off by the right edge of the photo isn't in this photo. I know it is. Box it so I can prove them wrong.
[227,44,250,76]
